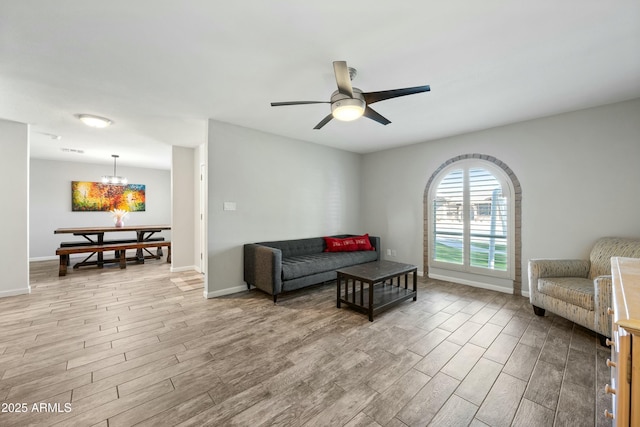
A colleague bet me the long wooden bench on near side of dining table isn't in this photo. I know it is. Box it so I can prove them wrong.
[56,240,171,276]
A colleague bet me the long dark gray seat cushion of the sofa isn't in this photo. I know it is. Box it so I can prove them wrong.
[282,251,378,280]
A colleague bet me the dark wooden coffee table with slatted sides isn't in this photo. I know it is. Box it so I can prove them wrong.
[336,261,418,322]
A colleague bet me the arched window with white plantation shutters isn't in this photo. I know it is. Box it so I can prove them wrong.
[425,157,516,289]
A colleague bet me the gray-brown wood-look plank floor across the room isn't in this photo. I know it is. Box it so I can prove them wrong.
[0,261,611,427]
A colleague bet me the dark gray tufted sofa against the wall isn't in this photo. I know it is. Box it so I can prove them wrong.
[244,234,380,303]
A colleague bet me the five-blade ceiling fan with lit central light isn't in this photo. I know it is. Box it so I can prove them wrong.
[271,61,431,129]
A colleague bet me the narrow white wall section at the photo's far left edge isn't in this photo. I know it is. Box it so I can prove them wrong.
[0,119,30,297]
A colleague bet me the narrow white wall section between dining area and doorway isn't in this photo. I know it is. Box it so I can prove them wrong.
[171,146,197,271]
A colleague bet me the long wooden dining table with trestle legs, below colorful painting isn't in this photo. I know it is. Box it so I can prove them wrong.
[53,224,171,266]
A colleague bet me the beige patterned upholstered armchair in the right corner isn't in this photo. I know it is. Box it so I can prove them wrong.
[529,237,640,345]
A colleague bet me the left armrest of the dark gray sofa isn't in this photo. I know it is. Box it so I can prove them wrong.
[244,243,282,295]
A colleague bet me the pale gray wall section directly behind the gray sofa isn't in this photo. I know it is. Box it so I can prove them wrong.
[205,120,365,297]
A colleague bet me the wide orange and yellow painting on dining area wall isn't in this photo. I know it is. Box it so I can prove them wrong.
[71,181,146,212]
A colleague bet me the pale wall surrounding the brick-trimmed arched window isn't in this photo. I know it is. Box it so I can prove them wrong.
[360,99,640,291]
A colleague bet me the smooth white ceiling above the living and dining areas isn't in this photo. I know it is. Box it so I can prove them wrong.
[0,0,640,169]
